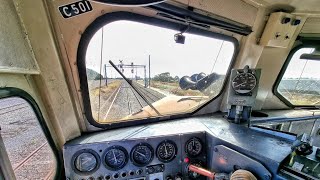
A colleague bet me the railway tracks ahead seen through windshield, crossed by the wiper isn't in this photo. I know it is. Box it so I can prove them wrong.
[102,81,164,122]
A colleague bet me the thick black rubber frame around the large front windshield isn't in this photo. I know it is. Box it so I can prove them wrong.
[77,11,239,129]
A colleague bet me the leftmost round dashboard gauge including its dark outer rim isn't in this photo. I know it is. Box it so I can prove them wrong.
[72,149,100,173]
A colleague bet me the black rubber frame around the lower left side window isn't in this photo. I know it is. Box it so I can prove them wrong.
[0,87,63,179]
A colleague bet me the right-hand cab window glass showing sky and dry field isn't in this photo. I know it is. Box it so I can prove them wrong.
[277,48,320,106]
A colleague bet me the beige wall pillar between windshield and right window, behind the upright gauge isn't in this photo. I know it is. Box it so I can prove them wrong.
[221,7,306,111]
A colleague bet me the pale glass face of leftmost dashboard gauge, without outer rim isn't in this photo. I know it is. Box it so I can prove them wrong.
[74,152,98,173]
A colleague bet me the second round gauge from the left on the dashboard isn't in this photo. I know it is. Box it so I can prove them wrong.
[104,146,128,170]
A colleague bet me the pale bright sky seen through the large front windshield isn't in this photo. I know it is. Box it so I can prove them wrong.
[86,21,234,78]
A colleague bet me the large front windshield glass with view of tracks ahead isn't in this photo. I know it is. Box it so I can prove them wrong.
[86,21,235,123]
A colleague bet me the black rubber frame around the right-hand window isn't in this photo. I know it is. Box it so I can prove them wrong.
[273,41,319,109]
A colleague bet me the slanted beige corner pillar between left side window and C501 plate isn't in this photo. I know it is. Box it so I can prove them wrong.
[15,0,80,144]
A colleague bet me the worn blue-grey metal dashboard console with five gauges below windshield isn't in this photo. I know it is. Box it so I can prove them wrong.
[63,114,295,180]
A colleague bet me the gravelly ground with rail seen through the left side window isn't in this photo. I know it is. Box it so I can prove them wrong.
[0,98,56,180]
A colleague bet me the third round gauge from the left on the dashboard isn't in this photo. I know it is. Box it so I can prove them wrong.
[131,143,153,166]
